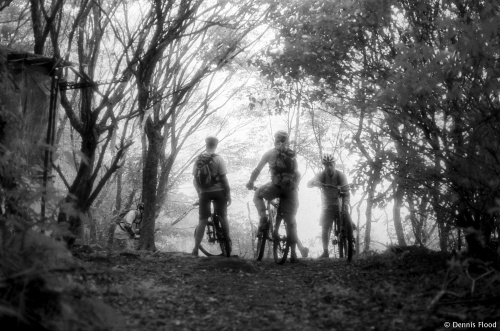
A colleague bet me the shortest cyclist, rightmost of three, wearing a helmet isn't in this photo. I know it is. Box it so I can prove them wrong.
[307,154,349,258]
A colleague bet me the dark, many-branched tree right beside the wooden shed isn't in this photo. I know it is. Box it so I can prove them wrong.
[22,0,139,244]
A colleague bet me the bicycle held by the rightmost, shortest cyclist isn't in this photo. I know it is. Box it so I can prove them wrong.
[323,184,354,262]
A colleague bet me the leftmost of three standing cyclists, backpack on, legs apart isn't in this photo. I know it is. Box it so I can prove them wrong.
[192,136,231,256]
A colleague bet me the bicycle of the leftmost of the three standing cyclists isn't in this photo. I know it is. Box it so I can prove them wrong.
[194,201,231,257]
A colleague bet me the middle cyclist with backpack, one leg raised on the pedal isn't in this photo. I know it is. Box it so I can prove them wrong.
[246,130,300,263]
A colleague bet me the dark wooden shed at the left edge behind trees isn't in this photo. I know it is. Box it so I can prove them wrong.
[0,45,72,174]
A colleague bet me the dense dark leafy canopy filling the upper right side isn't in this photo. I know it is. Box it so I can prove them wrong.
[261,0,500,260]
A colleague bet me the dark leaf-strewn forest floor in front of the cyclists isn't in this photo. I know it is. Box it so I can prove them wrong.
[67,250,500,330]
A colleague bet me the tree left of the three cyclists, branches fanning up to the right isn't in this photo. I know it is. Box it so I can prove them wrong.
[117,0,263,250]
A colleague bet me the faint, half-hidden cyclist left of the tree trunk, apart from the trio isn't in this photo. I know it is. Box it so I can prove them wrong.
[114,202,144,250]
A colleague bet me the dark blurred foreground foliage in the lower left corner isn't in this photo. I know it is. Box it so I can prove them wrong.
[0,105,85,330]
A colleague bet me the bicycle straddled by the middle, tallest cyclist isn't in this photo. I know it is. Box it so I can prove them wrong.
[254,188,290,264]
